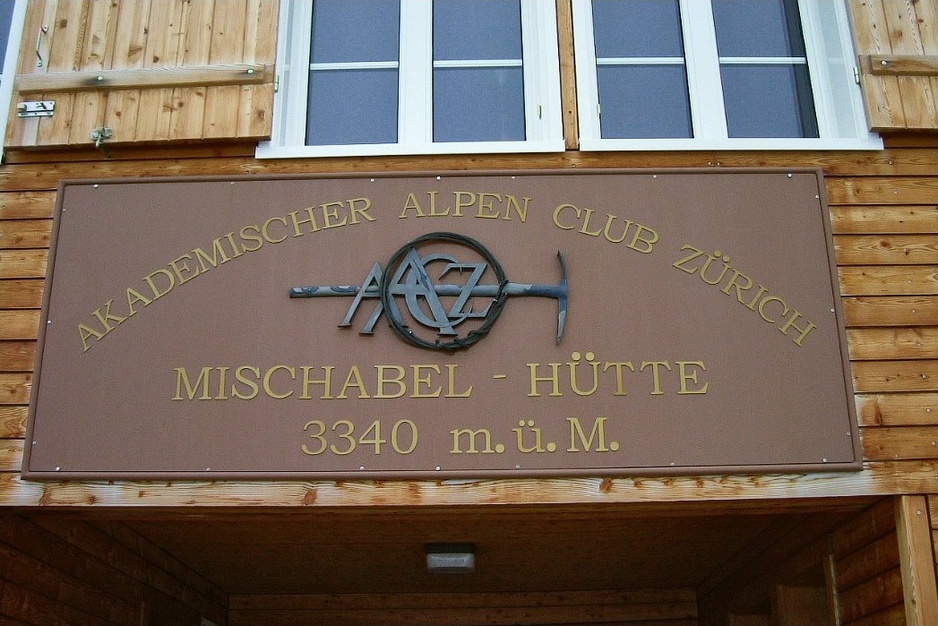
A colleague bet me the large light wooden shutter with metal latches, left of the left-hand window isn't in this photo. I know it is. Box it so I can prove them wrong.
[6,0,278,147]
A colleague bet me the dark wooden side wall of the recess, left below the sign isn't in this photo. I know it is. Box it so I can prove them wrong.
[0,509,227,626]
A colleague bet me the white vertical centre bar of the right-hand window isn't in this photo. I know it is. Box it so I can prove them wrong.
[681,0,727,139]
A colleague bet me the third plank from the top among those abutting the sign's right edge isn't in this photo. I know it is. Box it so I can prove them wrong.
[834,235,938,265]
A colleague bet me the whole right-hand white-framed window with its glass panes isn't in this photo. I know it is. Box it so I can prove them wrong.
[573,0,881,150]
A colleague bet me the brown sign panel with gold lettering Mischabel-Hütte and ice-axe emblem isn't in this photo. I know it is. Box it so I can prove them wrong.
[23,170,860,479]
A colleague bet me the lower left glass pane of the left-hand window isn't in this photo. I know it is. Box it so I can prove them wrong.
[306,69,397,146]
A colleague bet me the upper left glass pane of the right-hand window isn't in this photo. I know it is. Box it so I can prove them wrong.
[593,0,680,58]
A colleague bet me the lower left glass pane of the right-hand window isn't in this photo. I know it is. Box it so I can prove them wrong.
[596,65,692,139]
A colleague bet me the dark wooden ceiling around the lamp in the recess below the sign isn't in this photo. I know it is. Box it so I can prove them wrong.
[100,501,863,595]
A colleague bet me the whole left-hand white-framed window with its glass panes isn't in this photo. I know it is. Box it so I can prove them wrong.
[257,0,564,157]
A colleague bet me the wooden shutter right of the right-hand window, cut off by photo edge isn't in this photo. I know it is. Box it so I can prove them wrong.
[850,0,938,132]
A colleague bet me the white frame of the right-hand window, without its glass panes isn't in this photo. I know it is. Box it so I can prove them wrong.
[573,0,883,151]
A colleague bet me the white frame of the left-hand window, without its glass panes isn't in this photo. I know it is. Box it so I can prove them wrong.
[256,0,564,158]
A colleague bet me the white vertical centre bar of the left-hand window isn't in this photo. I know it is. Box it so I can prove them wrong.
[398,0,433,144]
